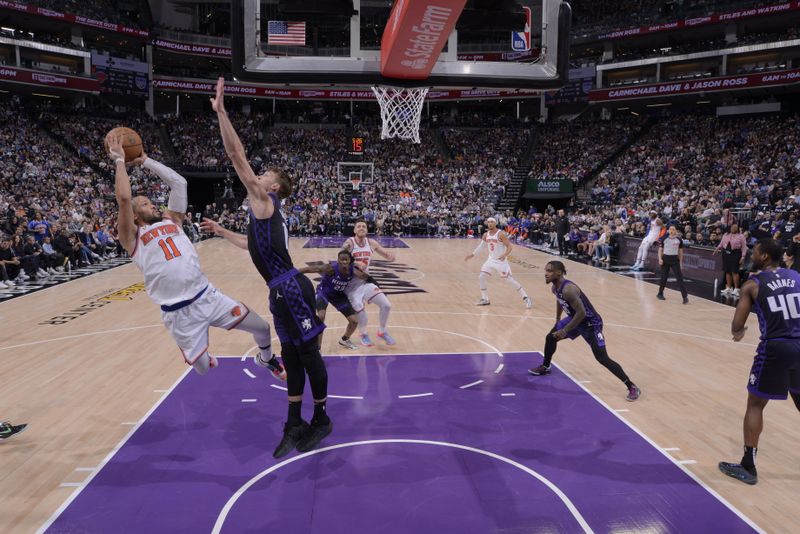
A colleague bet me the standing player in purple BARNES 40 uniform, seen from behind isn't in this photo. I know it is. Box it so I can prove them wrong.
[719,239,800,485]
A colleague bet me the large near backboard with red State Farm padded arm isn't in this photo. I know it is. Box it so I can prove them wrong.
[231,0,571,91]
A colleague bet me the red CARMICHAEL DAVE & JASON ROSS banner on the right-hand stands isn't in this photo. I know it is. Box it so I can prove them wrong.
[589,69,800,102]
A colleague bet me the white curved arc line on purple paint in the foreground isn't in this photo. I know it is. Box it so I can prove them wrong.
[211,439,594,534]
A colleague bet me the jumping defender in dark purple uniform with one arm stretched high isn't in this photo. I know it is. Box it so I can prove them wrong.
[211,78,333,458]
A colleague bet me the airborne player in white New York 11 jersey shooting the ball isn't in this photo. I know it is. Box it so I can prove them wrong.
[106,137,286,380]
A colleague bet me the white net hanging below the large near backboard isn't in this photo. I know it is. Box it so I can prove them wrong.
[372,85,430,143]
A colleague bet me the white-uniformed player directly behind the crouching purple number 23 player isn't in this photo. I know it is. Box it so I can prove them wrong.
[342,221,395,347]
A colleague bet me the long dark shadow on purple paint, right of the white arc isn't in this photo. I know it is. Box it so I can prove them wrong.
[511,440,695,485]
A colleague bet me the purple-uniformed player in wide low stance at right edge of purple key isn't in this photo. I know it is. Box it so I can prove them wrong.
[528,261,642,401]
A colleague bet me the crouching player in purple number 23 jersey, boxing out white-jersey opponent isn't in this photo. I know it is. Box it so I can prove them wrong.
[299,250,369,350]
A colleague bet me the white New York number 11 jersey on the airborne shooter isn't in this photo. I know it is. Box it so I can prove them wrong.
[131,219,208,305]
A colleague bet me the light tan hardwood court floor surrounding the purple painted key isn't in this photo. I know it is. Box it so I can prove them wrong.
[0,239,800,532]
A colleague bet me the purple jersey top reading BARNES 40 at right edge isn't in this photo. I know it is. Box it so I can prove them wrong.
[751,269,800,340]
